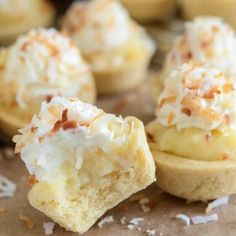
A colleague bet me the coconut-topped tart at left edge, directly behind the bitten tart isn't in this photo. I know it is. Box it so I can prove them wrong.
[0,29,96,137]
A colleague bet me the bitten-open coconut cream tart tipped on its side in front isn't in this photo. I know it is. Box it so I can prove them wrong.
[13,97,155,233]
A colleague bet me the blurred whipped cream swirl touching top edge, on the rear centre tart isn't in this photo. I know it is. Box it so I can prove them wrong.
[62,0,132,53]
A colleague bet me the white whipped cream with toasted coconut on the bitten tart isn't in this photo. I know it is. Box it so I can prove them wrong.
[13,97,129,182]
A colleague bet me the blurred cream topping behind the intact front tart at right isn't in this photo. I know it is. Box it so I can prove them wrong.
[164,17,236,75]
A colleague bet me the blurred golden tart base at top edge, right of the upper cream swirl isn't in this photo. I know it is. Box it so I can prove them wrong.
[121,0,176,23]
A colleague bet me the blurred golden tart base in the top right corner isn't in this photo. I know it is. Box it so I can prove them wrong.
[178,0,236,28]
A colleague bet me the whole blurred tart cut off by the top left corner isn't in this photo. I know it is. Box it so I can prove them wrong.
[0,0,55,45]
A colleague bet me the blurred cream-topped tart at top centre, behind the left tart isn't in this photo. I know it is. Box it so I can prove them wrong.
[62,0,155,94]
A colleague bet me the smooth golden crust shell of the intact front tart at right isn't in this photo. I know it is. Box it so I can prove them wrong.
[151,144,236,201]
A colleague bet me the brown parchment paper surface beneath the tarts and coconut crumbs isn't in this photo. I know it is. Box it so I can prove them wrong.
[0,84,236,236]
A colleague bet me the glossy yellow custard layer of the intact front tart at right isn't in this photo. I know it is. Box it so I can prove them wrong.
[146,120,236,161]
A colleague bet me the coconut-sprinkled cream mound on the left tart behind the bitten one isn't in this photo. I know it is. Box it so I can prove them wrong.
[0,29,93,109]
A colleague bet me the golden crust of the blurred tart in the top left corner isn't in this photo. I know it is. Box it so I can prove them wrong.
[0,0,55,45]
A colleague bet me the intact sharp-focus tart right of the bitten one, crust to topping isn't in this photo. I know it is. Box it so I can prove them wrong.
[146,64,236,201]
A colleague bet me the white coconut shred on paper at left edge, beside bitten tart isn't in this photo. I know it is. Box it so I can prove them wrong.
[0,175,16,198]
